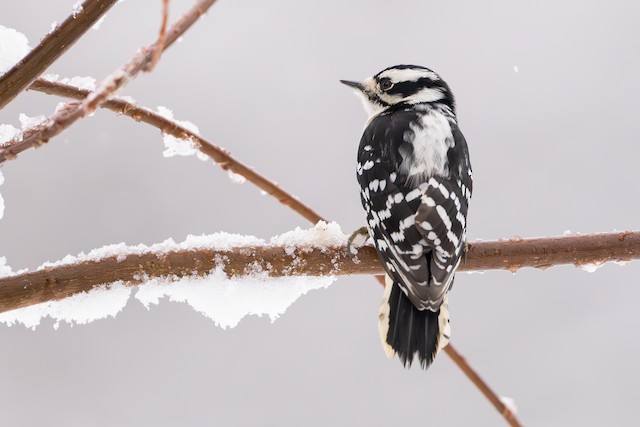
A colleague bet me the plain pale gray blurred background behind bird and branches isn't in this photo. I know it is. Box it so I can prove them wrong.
[0,0,640,426]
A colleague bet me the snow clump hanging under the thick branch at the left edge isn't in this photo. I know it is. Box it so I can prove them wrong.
[0,282,131,330]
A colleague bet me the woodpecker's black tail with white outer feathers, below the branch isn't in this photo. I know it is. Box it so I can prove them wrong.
[379,277,451,369]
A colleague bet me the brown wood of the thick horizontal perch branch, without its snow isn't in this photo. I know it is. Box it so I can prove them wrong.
[0,232,640,312]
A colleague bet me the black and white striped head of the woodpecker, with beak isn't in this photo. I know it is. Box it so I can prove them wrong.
[340,65,455,116]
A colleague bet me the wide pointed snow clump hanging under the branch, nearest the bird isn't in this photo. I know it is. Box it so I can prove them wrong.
[135,268,335,329]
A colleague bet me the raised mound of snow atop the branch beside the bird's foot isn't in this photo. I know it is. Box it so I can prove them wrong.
[270,221,347,255]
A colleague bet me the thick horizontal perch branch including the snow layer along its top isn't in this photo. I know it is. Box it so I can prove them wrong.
[0,229,640,312]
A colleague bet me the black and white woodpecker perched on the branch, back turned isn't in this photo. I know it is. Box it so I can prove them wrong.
[340,65,473,369]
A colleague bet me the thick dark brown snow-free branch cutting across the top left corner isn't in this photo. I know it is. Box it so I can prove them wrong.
[0,0,117,109]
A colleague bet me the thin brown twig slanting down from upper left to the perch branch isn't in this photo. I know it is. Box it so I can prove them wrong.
[29,79,322,224]
